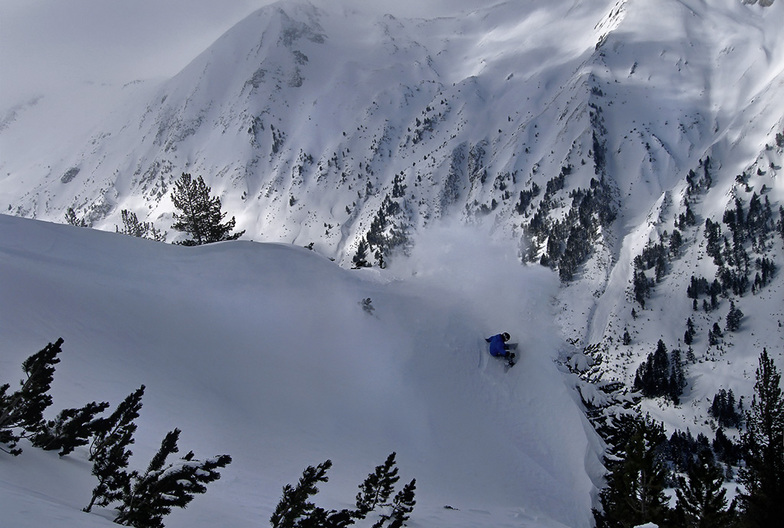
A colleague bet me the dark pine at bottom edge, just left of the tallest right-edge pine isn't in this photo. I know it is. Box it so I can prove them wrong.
[675,450,734,528]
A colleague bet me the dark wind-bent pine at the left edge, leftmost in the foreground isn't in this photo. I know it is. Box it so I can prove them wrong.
[0,338,63,455]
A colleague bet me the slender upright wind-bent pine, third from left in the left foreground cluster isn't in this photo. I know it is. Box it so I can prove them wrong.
[84,385,144,512]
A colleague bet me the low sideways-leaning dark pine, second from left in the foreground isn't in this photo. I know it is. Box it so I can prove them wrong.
[30,402,109,456]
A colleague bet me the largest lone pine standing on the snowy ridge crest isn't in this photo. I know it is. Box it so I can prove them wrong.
[172,172,245,246]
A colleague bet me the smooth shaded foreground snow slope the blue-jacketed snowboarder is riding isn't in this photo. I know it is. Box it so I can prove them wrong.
[0,216,600,528]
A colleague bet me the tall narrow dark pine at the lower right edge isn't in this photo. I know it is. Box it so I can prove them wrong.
[738,349,784,528]
